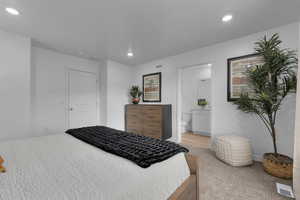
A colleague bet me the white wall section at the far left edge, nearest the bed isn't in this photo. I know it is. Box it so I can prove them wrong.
[0,31,31,140]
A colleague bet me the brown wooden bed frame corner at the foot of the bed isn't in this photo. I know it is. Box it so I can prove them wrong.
[168,154,200,200]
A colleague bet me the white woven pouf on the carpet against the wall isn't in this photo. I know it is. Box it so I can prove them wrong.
[213,135,253,167]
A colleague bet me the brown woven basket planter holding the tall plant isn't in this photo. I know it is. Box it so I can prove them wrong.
[263,153,293,179]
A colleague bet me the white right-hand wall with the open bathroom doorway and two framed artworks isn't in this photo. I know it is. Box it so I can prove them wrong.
[135,23,299,159]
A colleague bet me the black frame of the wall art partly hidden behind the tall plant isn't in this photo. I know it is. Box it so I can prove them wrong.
[227,53,260,102]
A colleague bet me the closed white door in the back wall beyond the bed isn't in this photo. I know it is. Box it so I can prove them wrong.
[68,70,99,128]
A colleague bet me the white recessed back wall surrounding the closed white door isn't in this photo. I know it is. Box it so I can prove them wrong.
[32,47,105,135]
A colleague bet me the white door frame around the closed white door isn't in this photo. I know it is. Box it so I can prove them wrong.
[65,67,100,129]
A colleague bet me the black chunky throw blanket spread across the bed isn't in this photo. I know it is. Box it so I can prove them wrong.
[66,126,188,168]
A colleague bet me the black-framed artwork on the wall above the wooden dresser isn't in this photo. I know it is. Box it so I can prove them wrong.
[143,72,161,102]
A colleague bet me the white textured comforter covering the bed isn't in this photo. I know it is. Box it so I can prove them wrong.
[0,134,189,200]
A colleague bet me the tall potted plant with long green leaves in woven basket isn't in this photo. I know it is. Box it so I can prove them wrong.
[234,34,298,178]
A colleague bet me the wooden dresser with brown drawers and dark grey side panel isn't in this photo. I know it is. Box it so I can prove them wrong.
[125,104,172,139]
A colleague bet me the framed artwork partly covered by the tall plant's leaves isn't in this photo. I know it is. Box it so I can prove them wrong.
[227,54,264,101]
